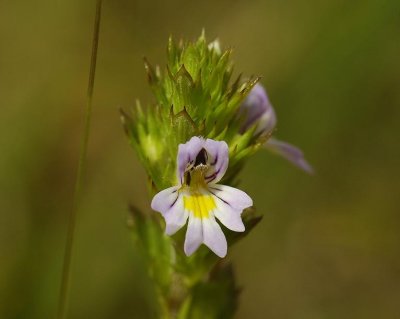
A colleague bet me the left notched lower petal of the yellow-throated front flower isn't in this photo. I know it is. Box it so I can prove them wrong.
[151,186,188,235]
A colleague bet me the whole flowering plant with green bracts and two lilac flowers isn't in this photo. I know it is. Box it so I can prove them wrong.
[122,35,311,319]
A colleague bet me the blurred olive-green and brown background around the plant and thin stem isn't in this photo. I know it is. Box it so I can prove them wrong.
[0,0,400,319]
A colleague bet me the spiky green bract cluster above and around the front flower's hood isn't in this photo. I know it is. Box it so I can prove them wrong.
[122,34,266,190]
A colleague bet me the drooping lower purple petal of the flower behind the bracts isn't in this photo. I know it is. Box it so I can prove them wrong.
[265,138,314,174]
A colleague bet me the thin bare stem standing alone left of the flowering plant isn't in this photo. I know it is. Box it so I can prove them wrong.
[57,0,102,319]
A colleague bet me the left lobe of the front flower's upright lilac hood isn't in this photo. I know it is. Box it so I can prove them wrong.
[177,136,205,185]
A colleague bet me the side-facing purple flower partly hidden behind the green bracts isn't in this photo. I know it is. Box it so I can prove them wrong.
[240,83,313,173]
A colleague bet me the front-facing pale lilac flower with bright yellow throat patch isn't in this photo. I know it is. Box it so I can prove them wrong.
[151,136,253,257]
